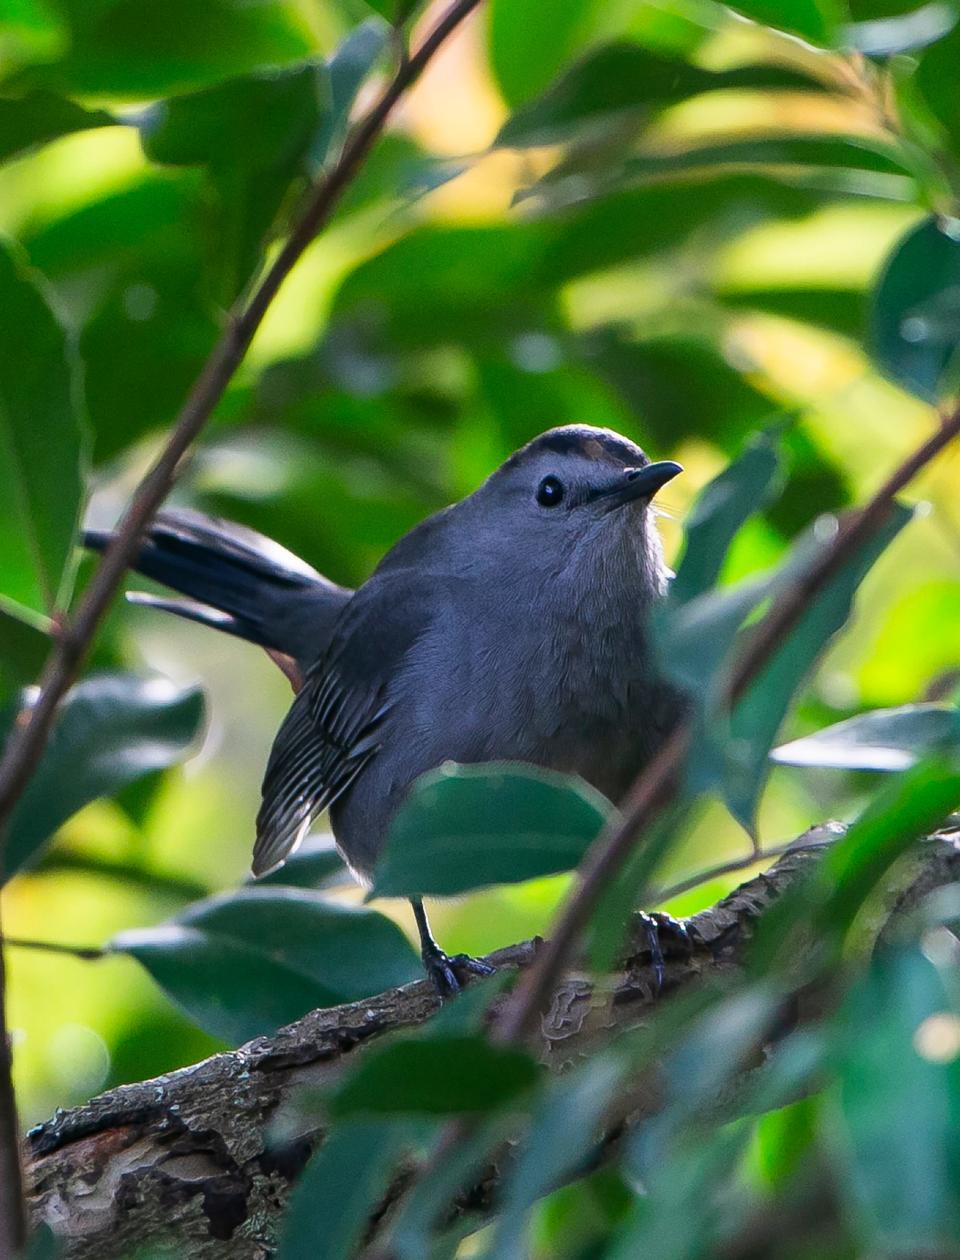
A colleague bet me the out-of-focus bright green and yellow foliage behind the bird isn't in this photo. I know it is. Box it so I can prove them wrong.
[0,0,960,1123]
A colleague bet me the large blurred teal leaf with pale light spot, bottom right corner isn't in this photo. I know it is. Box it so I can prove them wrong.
[828,949,960,1256]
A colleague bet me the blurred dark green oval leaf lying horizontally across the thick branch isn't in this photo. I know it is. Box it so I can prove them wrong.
[330,1036,539,1116]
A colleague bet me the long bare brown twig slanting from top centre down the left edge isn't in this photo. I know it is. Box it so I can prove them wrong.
[0,0,480,1260]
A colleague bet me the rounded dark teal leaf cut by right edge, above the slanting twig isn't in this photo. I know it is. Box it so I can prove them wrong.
[869,211,960,402]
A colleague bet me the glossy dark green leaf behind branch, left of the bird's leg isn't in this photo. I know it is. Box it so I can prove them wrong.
[110,887,421,1045]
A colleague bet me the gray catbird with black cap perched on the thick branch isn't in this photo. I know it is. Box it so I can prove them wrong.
[86,425,682,993]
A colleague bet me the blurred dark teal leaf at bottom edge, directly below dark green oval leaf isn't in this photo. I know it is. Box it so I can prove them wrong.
[277,1121,406,1260]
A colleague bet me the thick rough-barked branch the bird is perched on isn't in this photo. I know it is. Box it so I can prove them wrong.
[26,824,960,1260]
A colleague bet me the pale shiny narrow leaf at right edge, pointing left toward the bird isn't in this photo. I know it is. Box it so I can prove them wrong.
[771,704,960,770]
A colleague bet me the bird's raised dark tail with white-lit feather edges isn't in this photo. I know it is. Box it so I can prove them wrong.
[83,510,351,669]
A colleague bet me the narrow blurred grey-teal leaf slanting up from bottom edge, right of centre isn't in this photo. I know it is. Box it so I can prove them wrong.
[485,1055,626,1260]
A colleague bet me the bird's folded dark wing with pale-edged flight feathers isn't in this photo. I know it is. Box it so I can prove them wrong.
[253,573,428,874]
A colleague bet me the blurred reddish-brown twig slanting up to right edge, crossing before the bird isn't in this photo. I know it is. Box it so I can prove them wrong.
[491,407,960,1043]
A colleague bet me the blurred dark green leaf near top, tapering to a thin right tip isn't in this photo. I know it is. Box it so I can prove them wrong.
[496,42,815,147]
